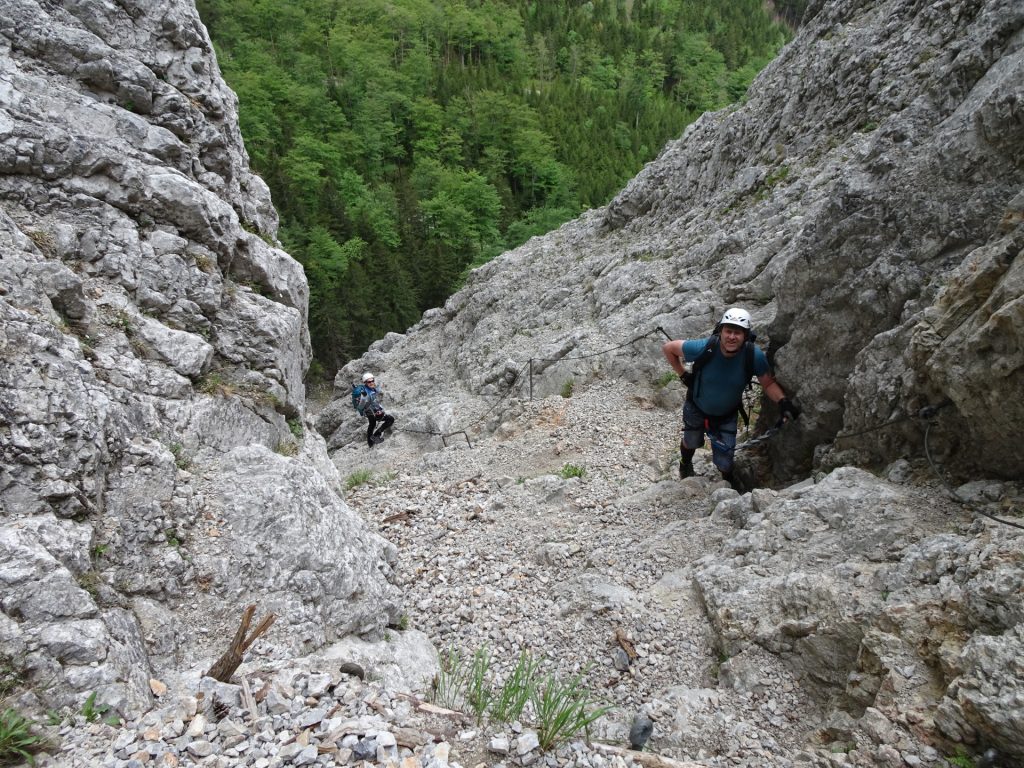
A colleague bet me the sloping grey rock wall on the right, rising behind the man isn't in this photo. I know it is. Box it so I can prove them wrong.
[331,0,1024,487]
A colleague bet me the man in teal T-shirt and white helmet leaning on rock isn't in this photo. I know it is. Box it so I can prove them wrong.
[662,307,800,490]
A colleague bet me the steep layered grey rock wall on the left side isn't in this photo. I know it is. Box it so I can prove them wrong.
[0,0,397,713]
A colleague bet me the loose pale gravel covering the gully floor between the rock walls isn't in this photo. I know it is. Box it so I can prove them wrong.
[39,379,1003,768]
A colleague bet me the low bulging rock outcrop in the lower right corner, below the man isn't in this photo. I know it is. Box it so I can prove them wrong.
[694,467,1024,758]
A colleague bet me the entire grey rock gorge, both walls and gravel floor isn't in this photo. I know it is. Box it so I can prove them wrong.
[0,0,1024,768]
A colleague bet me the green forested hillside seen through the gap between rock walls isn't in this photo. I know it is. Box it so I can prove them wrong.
[197,0,802,376]
